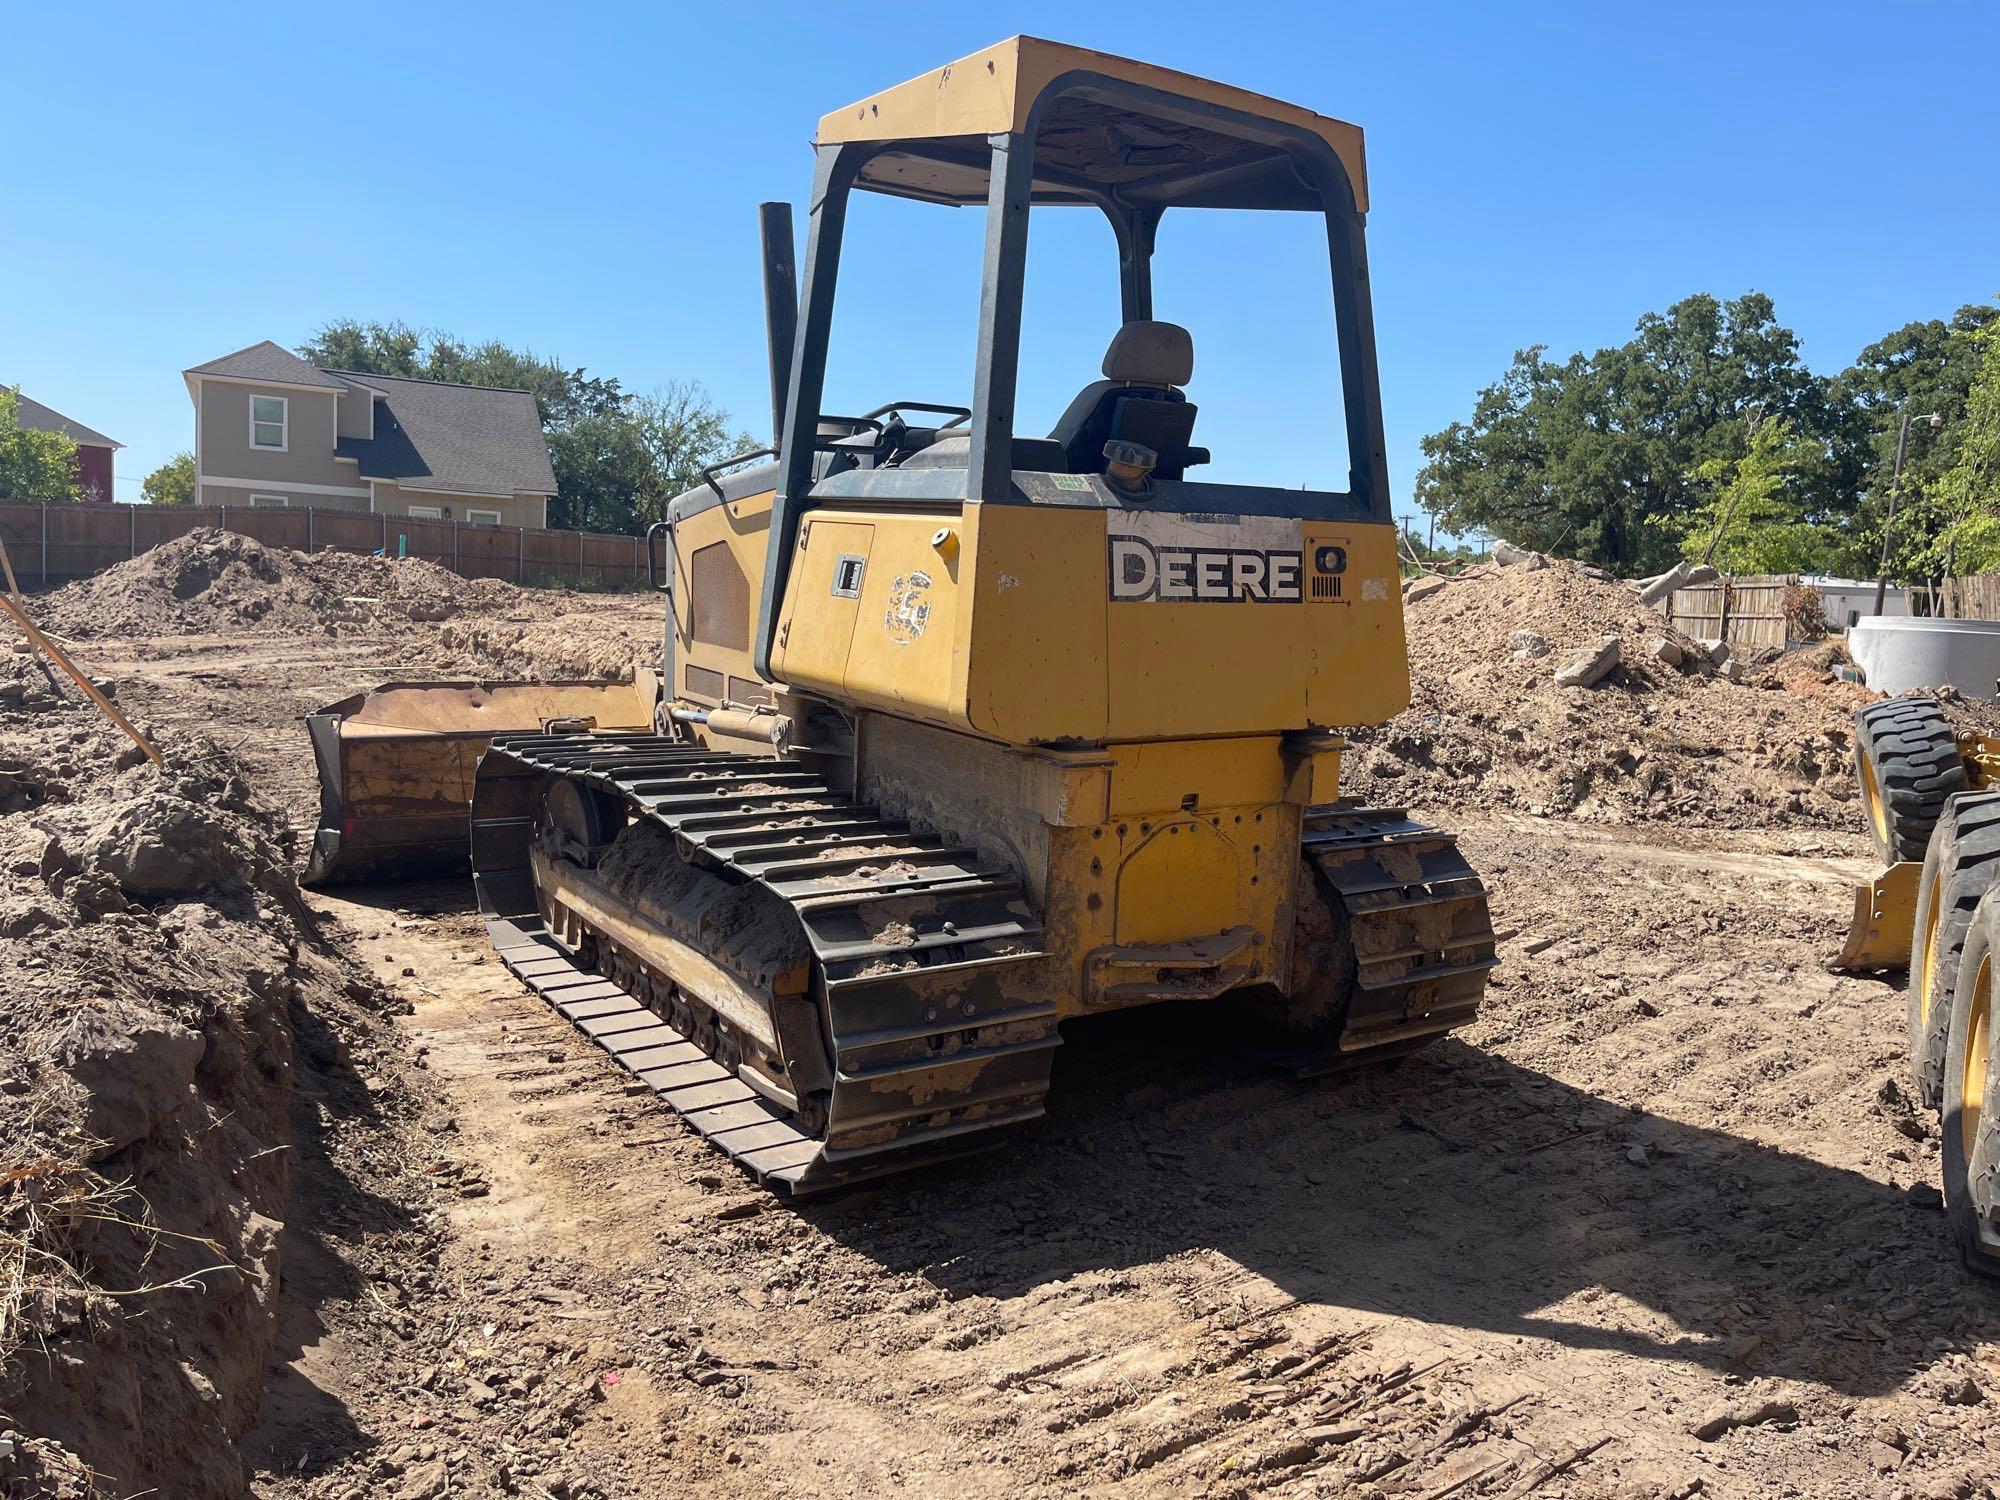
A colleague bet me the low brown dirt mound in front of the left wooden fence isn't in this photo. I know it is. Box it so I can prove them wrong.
[38,528,570,640]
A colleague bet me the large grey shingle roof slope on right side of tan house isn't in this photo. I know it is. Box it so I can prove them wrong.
[324,370,556,494]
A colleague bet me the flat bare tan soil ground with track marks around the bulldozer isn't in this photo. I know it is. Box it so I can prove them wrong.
[0,540,2000,1500]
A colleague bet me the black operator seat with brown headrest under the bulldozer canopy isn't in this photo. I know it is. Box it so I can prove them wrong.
[1048,322,1208,480]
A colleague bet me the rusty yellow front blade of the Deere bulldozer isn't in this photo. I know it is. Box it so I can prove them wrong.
[306,670,660,886]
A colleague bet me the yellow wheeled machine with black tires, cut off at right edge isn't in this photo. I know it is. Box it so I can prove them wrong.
[1834,696,2000,1276]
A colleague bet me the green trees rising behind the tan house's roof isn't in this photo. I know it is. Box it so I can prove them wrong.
[298,320,740,532]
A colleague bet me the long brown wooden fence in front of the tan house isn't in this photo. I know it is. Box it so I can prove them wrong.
[0,502,646,588]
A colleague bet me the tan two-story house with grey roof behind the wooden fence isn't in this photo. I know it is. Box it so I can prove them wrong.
[184,340,556,526]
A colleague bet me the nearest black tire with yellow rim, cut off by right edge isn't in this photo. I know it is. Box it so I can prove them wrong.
[1940,894,2000,1278]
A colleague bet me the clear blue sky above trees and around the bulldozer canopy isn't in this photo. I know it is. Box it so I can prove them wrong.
[0,0,2000,510]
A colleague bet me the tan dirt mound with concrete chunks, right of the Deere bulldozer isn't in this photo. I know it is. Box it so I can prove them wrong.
[1350,562,1872,828]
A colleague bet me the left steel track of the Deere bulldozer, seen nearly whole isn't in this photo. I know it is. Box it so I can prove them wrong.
[472,734,1060,1194]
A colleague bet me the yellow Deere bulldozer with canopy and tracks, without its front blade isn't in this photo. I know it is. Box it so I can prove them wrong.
[460,38,1494,1192]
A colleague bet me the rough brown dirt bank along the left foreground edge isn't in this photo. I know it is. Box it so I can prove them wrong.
[0,668,394,1496]
